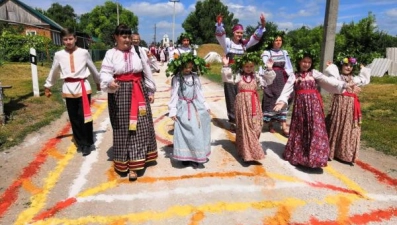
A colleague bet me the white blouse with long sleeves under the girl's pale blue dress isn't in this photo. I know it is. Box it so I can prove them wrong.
[168,73,210,117]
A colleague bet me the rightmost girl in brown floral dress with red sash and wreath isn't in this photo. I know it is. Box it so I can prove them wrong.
[327,57,371,163]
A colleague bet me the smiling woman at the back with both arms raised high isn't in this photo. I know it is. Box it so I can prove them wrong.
[215,14,266,129]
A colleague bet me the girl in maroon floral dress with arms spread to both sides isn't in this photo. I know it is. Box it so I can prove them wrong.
[274,51,349,168]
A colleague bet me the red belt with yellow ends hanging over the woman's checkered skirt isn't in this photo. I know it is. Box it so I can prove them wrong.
[114,73,146,130]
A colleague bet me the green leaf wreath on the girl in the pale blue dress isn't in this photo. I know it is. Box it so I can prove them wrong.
[165,53,208,77]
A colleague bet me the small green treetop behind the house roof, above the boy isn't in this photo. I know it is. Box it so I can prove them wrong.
[42,3,77,29]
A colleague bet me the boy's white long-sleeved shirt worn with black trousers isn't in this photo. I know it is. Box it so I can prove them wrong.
[44,48,100,98]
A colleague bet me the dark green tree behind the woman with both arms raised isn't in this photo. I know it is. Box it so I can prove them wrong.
[182,0,238,45]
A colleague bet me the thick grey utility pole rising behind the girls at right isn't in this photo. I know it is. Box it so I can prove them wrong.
[320,0,339,72]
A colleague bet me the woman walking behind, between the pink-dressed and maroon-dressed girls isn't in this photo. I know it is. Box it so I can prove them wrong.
[262,33,293,137]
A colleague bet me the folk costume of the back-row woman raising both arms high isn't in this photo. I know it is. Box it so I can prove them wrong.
[215,24,266,123]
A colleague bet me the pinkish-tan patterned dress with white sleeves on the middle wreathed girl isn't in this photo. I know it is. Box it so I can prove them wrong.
[221,67,275,161]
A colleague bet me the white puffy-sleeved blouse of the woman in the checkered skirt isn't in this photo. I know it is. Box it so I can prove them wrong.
[100,48,156,93]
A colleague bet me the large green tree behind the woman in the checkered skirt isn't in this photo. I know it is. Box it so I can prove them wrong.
[79,1,138,47]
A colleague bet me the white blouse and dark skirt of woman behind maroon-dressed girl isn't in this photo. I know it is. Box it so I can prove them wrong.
[262,49,293,122]
